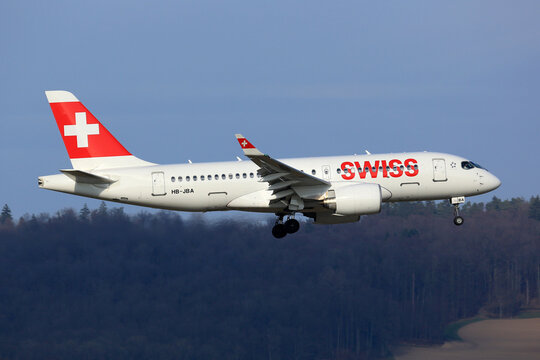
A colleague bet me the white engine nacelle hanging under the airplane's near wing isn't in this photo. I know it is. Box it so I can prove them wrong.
[323,184,382,215]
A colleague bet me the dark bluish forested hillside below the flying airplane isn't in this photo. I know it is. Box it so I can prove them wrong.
[0,197,540,360]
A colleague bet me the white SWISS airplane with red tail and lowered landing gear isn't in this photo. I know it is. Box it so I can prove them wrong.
[38,90,501,238]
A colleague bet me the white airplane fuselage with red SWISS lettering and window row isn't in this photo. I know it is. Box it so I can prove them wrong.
[39,152,500,212]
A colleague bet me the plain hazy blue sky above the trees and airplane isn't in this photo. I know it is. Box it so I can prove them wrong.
[0,1,540,216]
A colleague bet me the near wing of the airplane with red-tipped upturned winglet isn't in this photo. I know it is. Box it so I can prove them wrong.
[236,134,331,210]
